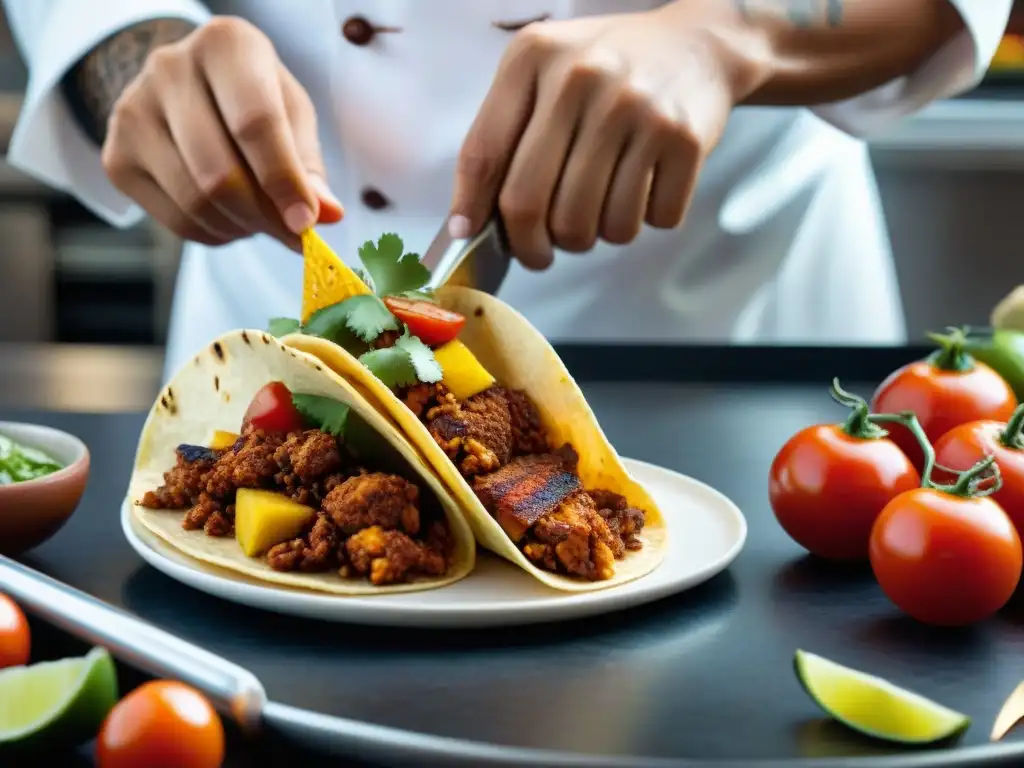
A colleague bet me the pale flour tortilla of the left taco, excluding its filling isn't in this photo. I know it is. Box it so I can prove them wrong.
[129,331,476,596]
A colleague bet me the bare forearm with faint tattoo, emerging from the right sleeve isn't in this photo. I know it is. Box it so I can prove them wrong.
[667,0,964,105]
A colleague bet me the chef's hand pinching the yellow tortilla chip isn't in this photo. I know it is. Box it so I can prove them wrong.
[102,16,343,249]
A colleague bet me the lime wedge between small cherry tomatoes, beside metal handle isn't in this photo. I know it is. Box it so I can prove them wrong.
[0,647,118,749]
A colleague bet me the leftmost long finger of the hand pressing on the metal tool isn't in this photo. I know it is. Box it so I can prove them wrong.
[449,33,539,238]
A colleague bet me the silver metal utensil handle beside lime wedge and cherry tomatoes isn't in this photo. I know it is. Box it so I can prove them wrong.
[0,555,266,732]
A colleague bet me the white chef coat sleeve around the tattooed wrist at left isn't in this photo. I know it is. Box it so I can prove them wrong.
[4,0,210,226]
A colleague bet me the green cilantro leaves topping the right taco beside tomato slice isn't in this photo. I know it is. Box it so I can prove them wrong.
[267,232,442,391]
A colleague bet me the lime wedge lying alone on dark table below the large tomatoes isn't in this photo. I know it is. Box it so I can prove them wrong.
[793,650,971,744]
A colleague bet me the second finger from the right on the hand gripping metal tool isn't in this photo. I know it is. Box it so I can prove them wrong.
[600,132,660,245]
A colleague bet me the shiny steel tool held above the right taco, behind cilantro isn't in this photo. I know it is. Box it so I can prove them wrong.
[422,214,512,295]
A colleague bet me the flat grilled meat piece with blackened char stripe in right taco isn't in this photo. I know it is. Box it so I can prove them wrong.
[473,454,583,543]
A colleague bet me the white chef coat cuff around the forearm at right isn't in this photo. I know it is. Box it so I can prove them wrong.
[813,0,1014,136]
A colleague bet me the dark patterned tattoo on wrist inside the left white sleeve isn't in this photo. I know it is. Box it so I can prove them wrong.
[60,18,196,145]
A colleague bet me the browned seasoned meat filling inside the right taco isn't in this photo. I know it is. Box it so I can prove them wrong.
[399,384,644,581]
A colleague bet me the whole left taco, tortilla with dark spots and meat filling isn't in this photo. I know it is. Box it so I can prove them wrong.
[129,331,476,596]
